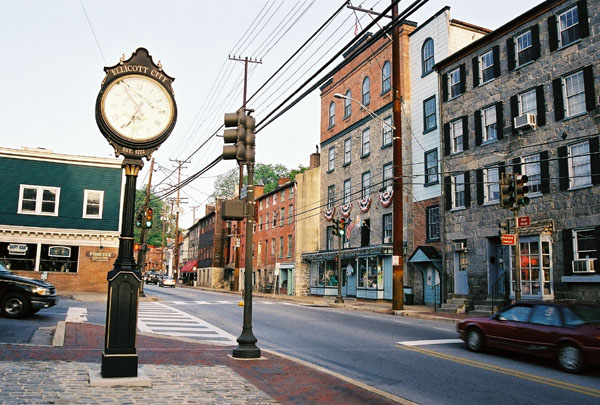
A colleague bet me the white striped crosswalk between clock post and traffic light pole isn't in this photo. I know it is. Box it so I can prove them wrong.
[138,302,237,346]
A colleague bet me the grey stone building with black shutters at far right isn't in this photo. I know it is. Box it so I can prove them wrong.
[435,0,600,309]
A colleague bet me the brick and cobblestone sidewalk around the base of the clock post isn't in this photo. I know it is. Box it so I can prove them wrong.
[0,323,409,404]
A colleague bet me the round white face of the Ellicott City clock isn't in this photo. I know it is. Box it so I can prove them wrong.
[101,75,175,142]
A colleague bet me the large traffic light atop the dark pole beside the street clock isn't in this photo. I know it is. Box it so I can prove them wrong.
[223,110,256,163]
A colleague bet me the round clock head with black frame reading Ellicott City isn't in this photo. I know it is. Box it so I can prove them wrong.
[96,48,177,159]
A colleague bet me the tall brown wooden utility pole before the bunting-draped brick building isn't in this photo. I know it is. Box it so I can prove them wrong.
[392,0,404,310]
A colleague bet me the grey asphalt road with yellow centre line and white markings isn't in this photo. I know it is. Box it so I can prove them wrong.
[0,285,600,405]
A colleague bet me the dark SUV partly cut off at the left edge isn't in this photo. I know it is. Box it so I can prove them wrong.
[0,263,58,318]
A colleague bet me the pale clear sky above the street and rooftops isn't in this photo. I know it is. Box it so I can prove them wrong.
[0,0,542,228]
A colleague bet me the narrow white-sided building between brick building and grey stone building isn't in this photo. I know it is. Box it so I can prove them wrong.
[404,6,490,304]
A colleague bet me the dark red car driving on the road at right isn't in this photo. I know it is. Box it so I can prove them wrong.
[456,302,600,373]
